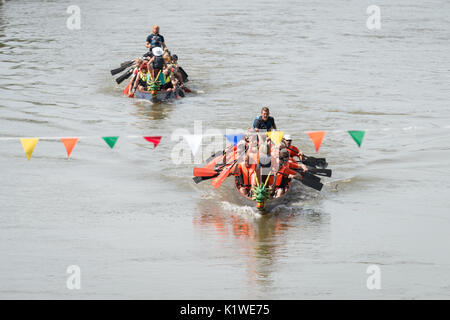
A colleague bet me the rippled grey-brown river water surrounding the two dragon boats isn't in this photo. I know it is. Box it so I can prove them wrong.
[0,0,450,299]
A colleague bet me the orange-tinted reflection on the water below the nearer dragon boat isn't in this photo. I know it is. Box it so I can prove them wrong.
[193,200,327,291]
